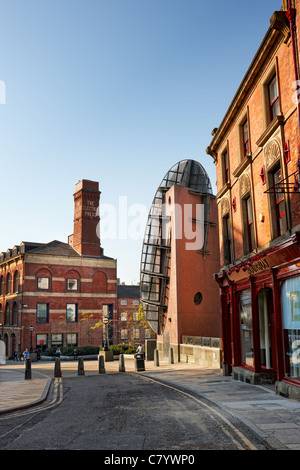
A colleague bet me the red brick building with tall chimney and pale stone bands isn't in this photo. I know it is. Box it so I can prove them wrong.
[0,180,117,356]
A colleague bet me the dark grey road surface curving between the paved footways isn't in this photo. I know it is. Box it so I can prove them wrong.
[0,373,264,452]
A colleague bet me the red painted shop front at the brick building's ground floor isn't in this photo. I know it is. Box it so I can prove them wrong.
[215,232,300,390]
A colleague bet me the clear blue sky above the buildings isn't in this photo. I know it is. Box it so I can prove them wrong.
[0,0,281,283]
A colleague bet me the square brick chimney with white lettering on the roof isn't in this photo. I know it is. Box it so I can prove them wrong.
[68,180,102,256]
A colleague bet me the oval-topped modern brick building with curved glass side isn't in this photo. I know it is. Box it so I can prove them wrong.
[140,160,221,362]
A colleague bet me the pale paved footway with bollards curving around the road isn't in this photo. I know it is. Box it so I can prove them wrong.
[0,358,300,450]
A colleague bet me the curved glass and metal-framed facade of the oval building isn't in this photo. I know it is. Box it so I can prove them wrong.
[140,160,212,334]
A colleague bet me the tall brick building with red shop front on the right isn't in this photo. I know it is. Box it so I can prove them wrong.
[207,0,300,394]
